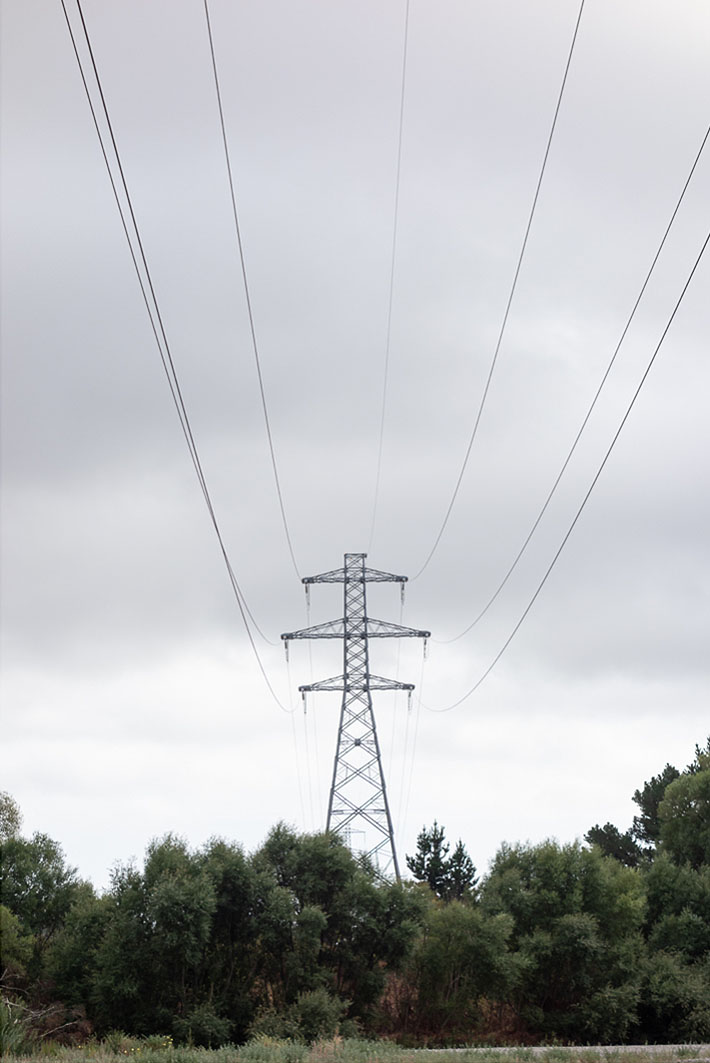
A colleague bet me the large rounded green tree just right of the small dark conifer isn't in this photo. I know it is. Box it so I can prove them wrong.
[481,841,644,1043]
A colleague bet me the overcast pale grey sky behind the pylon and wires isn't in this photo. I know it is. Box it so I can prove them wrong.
[0,0,710,887]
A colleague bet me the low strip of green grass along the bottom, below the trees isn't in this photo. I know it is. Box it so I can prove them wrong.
[4,1034,710,1063]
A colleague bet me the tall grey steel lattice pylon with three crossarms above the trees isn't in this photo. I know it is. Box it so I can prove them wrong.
[282,554,430,880]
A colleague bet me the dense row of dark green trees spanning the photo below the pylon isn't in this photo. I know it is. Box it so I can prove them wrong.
[0,739,710,1046]
